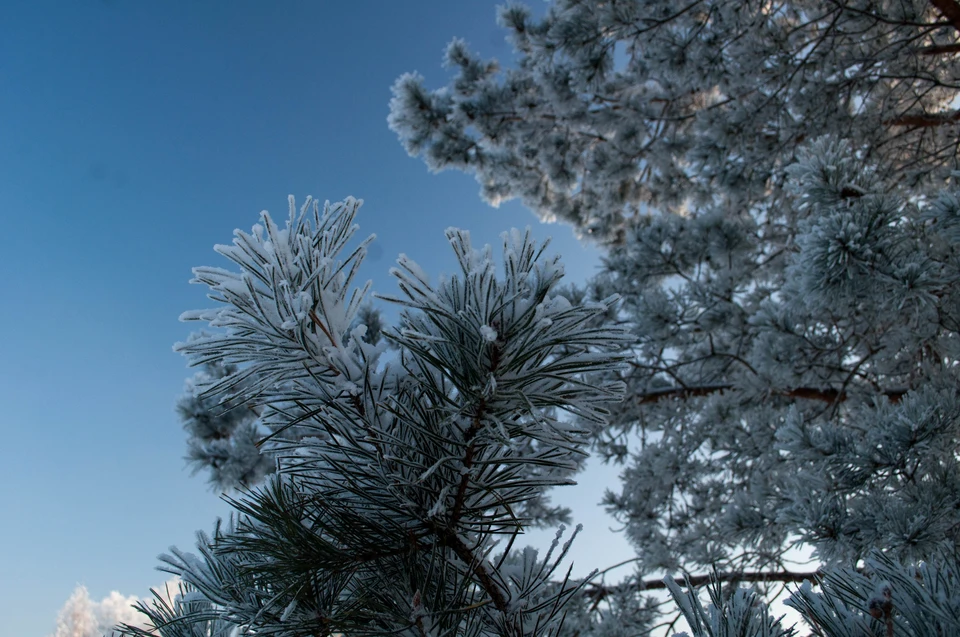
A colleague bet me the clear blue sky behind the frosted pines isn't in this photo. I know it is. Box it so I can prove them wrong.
[0,0,624,637]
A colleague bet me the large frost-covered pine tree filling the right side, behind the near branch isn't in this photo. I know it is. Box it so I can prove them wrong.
[389,0,960,628]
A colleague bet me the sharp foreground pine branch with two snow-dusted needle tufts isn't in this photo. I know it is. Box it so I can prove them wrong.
[124,198,630,637]
